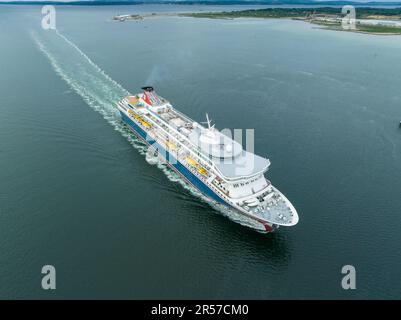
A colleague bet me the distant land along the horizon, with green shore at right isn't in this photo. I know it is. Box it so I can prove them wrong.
[5,0,401,35]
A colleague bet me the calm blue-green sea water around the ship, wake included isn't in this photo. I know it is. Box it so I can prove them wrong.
[0,6,401,299]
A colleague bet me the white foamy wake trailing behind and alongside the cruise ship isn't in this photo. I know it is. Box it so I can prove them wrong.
[31,31,264,231]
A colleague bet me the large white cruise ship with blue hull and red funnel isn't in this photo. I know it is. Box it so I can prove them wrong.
[117,87,299,232]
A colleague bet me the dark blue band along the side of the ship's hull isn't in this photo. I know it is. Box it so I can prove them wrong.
[120,111,225,205]
